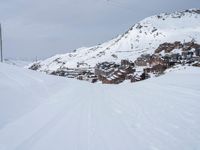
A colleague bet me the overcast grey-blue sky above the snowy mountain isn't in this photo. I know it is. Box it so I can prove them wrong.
[0,0,200,60]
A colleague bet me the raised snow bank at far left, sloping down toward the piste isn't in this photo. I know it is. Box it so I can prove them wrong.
[0,63,69,128]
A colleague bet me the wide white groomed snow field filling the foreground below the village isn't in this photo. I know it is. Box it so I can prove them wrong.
[0,64,200,150]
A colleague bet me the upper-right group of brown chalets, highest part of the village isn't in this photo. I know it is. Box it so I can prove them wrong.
[134,42,200,74]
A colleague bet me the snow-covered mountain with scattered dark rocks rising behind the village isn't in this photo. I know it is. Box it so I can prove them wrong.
[31,9,200,72]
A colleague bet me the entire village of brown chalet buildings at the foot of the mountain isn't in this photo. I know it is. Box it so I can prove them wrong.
[29,41,200,84]
